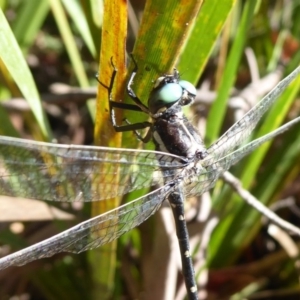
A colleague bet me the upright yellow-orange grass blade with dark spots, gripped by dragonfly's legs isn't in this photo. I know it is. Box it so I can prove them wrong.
[89,1,127,299]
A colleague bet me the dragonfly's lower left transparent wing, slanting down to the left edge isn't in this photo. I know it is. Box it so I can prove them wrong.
[0,186,172,270]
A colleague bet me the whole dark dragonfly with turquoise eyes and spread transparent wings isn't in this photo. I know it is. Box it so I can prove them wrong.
[0,58,300,300]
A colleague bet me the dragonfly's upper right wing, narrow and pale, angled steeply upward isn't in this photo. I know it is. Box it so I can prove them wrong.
[207,67,300,160]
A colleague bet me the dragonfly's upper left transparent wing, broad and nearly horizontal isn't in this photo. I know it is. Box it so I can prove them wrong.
[0,136,186,201]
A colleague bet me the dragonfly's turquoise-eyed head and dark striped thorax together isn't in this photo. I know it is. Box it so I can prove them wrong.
[148,69,206,160]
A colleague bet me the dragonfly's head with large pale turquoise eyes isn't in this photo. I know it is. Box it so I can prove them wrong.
[148,69,196,114]
